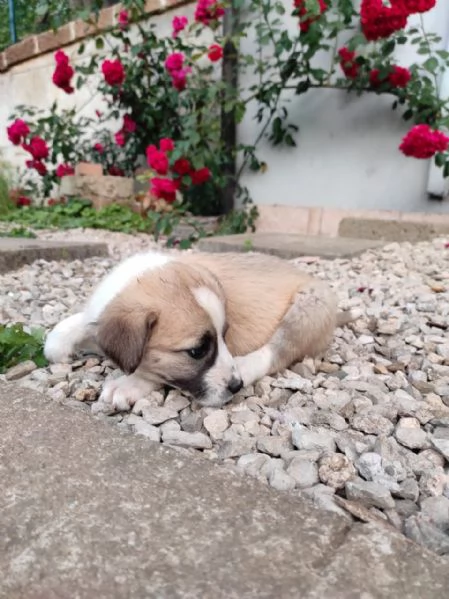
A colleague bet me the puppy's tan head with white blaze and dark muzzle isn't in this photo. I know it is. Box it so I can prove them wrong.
[97,262,242,406]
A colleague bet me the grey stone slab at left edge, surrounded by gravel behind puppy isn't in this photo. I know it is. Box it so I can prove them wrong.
[0,237,108,273]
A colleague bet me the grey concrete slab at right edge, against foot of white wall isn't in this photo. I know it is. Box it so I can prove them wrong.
[338,218,449,243]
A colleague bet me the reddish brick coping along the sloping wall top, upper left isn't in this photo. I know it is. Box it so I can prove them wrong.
[0,0,192,73]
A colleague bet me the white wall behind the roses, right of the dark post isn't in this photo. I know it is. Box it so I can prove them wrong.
[239,0,449,212]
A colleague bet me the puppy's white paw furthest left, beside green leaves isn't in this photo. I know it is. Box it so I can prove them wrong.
[44,312,88,362]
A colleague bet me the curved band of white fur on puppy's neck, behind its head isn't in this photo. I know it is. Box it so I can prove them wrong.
[84,252,172,323]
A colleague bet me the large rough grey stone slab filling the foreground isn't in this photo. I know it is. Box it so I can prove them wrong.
[0,383,449,599]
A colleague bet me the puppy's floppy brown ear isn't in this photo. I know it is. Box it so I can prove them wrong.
[96,307,157,374]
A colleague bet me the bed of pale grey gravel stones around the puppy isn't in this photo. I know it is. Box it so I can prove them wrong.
[0,231,449,555]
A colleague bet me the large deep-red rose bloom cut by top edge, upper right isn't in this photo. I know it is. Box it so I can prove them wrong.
[360,0,408,41]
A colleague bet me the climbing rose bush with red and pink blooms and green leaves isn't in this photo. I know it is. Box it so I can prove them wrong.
[8,0,449,216]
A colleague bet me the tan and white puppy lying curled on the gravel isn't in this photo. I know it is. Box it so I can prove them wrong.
[44,251,354,410]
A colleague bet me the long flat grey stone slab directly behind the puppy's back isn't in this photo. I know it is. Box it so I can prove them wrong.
[199,233,383,260]
